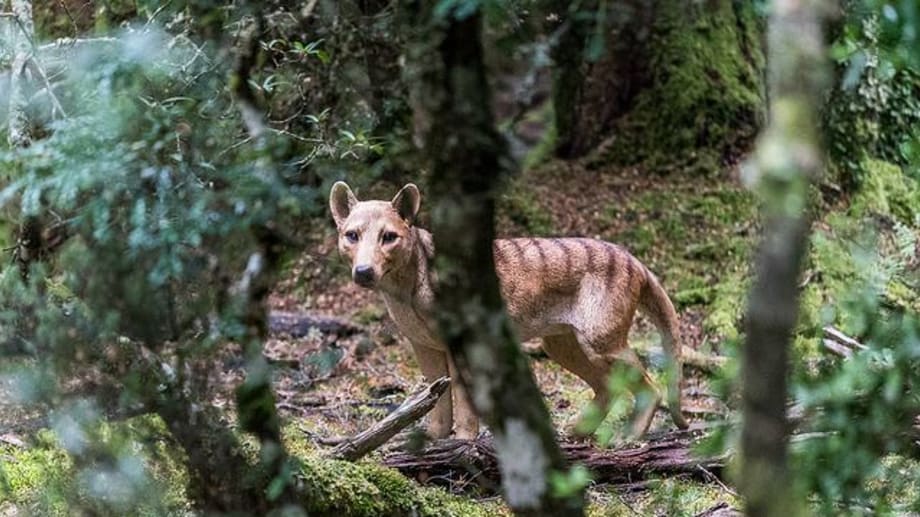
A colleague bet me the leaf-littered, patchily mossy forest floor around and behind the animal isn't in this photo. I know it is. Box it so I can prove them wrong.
[0,148,920,515]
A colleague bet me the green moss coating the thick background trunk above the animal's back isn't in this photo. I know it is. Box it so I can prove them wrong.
[591,0,765,174]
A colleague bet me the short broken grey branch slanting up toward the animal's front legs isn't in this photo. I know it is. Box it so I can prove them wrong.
[329,377,450,461]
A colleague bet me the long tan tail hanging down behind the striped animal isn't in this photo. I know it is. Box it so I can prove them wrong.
[639,269,688,429]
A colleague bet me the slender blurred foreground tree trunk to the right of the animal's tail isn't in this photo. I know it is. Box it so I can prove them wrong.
[741,0,827,517]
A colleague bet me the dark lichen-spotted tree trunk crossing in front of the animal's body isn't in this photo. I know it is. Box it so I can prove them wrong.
[410,6,583,515]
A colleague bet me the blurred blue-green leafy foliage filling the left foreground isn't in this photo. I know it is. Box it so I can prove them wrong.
[0,19,328,513]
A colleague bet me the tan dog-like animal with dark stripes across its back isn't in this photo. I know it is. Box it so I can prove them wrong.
[329,182,687,438]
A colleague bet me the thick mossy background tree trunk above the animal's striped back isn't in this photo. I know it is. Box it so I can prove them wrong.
[554,0,765,171]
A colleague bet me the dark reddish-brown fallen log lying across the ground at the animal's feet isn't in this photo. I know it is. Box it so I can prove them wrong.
[383,429,726,487]
